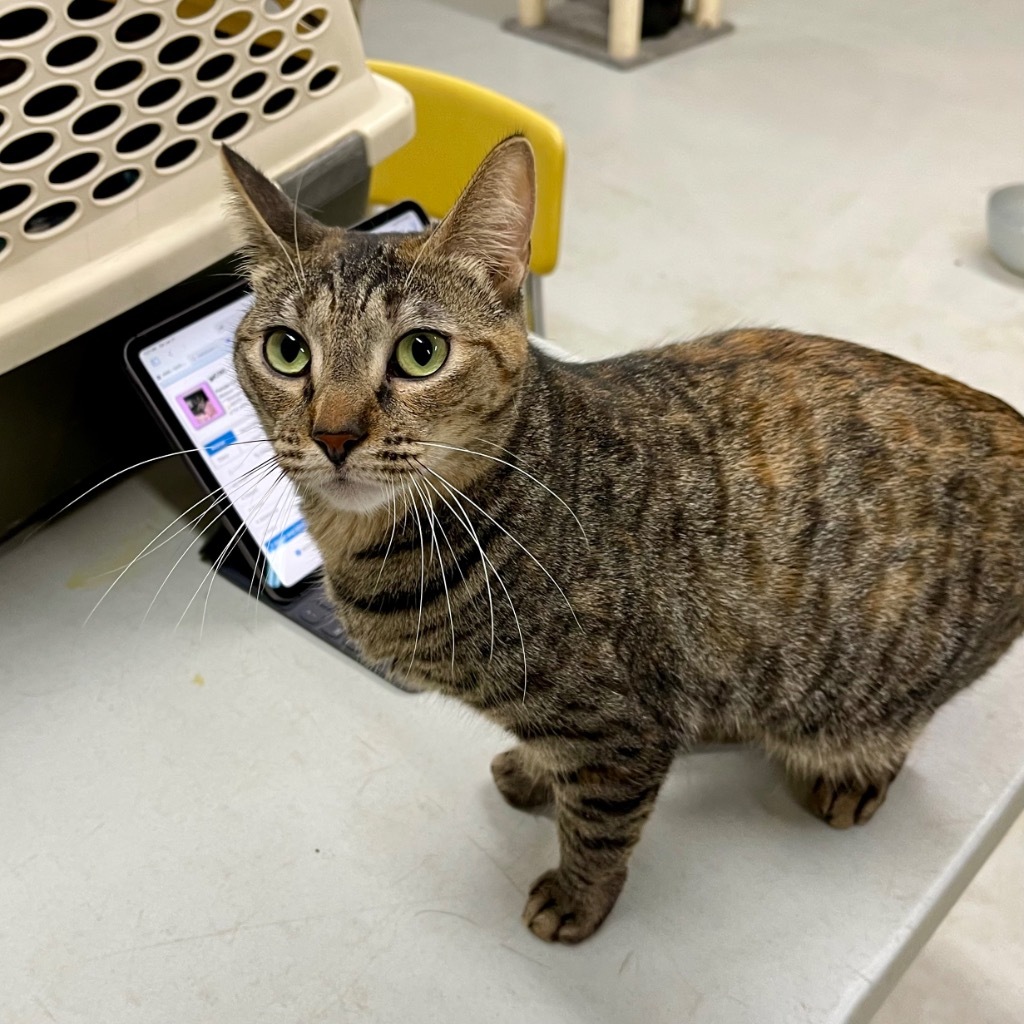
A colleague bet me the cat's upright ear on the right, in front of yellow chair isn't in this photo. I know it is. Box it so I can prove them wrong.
[425,135,537,299]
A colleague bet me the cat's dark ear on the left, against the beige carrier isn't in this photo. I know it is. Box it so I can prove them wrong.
[220,145,328,259]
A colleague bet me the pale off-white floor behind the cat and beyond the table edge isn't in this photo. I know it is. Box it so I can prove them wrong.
[365,0,1024,1024]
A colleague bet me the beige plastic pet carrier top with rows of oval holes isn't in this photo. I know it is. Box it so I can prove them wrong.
[0,0,414,373]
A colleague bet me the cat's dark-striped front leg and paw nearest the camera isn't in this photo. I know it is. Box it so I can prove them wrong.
[523,751,672,943]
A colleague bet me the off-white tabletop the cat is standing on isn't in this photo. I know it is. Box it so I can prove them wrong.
[0,467,1024,1024]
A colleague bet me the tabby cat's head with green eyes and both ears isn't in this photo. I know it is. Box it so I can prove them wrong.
[224,136,535,511]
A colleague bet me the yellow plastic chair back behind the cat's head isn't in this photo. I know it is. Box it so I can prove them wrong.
[367,60,565,334]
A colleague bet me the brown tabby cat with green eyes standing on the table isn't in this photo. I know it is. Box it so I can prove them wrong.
[225,137,1024,942]
